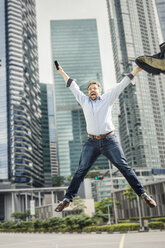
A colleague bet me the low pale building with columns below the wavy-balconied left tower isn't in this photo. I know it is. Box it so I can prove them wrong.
[0,187,67,222]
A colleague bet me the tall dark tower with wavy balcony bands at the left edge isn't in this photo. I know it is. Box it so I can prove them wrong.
[0,0,43,187]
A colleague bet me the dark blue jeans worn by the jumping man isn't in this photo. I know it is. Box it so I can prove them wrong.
[65,134,145,201]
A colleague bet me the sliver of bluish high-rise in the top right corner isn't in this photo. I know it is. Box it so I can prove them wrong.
[155,0,165,41]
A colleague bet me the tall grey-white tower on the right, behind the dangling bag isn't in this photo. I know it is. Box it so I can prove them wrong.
[107,0,165,168]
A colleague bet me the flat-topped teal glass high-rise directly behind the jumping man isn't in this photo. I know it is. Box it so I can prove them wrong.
[51,19,108,176]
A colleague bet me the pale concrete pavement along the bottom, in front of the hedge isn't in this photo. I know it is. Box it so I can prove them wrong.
[0,231,165,248]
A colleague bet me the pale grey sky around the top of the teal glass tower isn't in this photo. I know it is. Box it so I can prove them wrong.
[36,0,115,89]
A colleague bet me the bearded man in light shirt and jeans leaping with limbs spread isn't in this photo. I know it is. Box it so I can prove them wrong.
[55,65,156,212]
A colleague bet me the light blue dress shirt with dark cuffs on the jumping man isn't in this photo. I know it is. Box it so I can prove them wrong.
[69,76,132,135]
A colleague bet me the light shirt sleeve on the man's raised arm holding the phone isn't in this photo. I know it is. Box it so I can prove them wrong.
[67,78,87,105]
